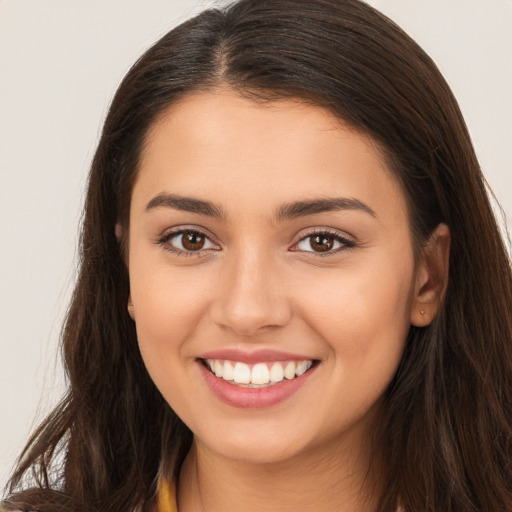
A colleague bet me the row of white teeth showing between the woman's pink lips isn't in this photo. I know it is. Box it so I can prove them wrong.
[201,359,318,388]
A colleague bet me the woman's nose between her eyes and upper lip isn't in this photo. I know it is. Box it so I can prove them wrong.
[211,250,292,336]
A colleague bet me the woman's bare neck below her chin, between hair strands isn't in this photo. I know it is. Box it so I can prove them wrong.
[178,428,380,512]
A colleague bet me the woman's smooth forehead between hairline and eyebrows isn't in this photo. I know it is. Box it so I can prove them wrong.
[134,91,406,226]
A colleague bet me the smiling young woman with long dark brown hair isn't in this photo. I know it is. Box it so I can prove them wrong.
[4,0,512,512]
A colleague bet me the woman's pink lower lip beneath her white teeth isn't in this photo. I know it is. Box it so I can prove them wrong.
[198,361,316,409]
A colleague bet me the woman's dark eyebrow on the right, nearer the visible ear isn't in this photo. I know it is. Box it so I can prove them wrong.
[275,197,377,222]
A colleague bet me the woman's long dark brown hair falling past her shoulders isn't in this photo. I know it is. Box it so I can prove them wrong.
[5,0,512,512]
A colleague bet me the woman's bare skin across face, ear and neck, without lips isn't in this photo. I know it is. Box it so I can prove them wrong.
[128,90,449,512]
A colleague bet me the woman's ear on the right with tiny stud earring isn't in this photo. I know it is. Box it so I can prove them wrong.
[411,224,450,327]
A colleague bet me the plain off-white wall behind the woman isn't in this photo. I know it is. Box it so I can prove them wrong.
[0,0,512,487]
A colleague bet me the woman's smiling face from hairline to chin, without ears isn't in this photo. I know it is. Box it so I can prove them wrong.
[128,91,424,462]
